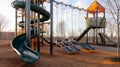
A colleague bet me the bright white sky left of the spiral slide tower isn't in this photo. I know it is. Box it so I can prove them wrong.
[0,0,15,31]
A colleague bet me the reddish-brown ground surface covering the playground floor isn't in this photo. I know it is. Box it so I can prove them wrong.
[0,41,120,67]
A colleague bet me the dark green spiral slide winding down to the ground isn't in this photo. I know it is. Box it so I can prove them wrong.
[11,1,50,63]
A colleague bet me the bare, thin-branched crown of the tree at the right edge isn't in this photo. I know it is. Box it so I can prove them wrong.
[103,0,120,34]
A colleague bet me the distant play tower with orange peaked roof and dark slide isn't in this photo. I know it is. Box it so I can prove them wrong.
[77,0,106,44]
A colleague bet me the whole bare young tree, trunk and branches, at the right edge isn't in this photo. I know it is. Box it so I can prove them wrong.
[104,0,120,56]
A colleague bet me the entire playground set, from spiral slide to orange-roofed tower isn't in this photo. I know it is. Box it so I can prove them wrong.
[11,0,119,63]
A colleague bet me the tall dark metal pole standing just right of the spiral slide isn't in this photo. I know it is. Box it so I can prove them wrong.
[50,0,53,55]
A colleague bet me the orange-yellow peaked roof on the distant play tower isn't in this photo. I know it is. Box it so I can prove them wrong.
[87,0,105,13]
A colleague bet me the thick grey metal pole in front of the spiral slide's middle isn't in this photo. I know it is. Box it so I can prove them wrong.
[26,0,31,47]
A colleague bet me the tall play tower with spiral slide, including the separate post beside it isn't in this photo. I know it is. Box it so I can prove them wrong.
[11,0,53,63]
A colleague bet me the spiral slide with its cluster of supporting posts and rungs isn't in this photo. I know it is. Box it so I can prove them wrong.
[11,0,50,63]
